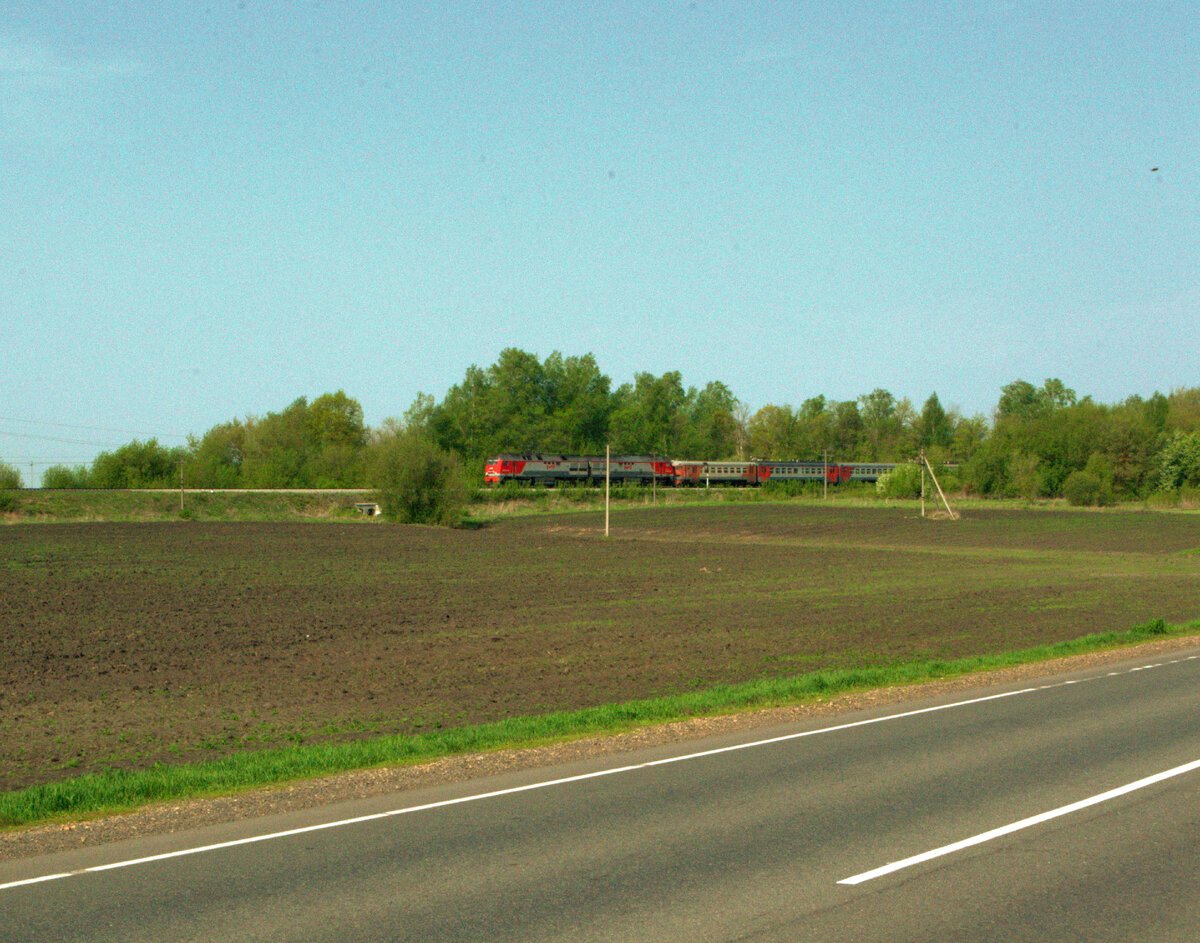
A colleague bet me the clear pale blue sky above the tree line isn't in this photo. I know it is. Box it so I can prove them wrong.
[0,0,1200,482]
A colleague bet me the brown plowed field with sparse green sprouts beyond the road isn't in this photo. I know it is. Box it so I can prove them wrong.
[0,505,1200,789]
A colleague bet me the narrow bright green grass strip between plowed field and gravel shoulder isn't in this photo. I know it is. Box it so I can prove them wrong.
[0,619,1200,828]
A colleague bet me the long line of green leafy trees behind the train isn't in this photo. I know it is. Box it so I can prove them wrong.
[9,348,1200,504]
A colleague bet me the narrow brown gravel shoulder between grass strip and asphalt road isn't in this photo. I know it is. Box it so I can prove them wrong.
[0,636,1200,860]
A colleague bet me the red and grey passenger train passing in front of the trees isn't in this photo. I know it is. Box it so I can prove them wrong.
[484,452,895,488]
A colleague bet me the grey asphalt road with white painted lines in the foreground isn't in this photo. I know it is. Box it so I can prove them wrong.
[0,650,1200,943]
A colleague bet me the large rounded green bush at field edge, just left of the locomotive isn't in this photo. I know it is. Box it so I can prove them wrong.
[371,430,470,525]
